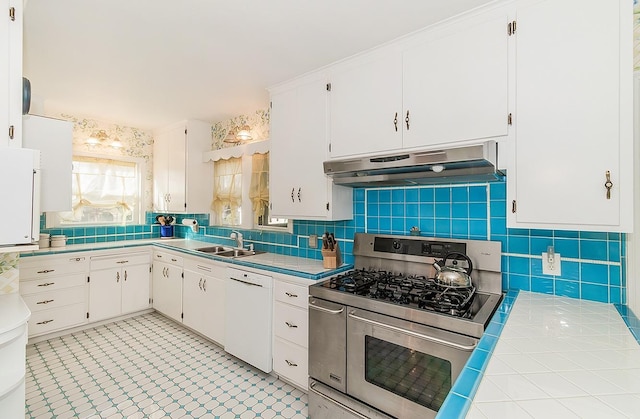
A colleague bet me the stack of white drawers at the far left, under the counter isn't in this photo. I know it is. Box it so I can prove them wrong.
[19,253,89,337]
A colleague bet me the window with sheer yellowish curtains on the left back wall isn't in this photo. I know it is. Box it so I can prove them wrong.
[47,156,142,227]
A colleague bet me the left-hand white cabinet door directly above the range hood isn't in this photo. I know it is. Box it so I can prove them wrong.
[329,52,403,158]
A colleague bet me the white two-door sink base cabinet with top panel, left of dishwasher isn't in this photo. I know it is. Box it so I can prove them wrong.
[182,259,226,346]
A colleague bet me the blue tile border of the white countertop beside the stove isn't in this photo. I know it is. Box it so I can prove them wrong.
[436,290,519,419]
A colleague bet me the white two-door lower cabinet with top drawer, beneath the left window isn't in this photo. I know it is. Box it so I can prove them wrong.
[89,251,151,322]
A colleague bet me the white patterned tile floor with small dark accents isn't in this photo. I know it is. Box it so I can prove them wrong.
[26,313,307,419]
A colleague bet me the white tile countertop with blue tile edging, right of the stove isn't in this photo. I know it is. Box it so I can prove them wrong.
[438,291,640,419]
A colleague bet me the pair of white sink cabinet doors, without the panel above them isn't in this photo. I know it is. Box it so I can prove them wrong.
[183,270,225,345]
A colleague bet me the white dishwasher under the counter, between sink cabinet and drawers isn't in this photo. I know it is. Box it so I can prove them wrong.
[224,268,273,372]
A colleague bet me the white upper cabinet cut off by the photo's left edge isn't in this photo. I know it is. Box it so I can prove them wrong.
[0,0,23,147]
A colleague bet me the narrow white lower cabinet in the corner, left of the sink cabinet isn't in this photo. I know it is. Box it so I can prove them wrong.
[152,251,184,322]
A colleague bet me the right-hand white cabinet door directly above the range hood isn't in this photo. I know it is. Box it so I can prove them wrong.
[402,15,508,148]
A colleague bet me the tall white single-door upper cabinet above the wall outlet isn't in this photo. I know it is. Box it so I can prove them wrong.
[507,0,633,232]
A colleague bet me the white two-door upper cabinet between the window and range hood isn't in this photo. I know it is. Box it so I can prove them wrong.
[269,74,353,220]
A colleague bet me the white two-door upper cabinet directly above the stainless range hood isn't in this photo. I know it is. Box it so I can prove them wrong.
[329,12,509,158]
